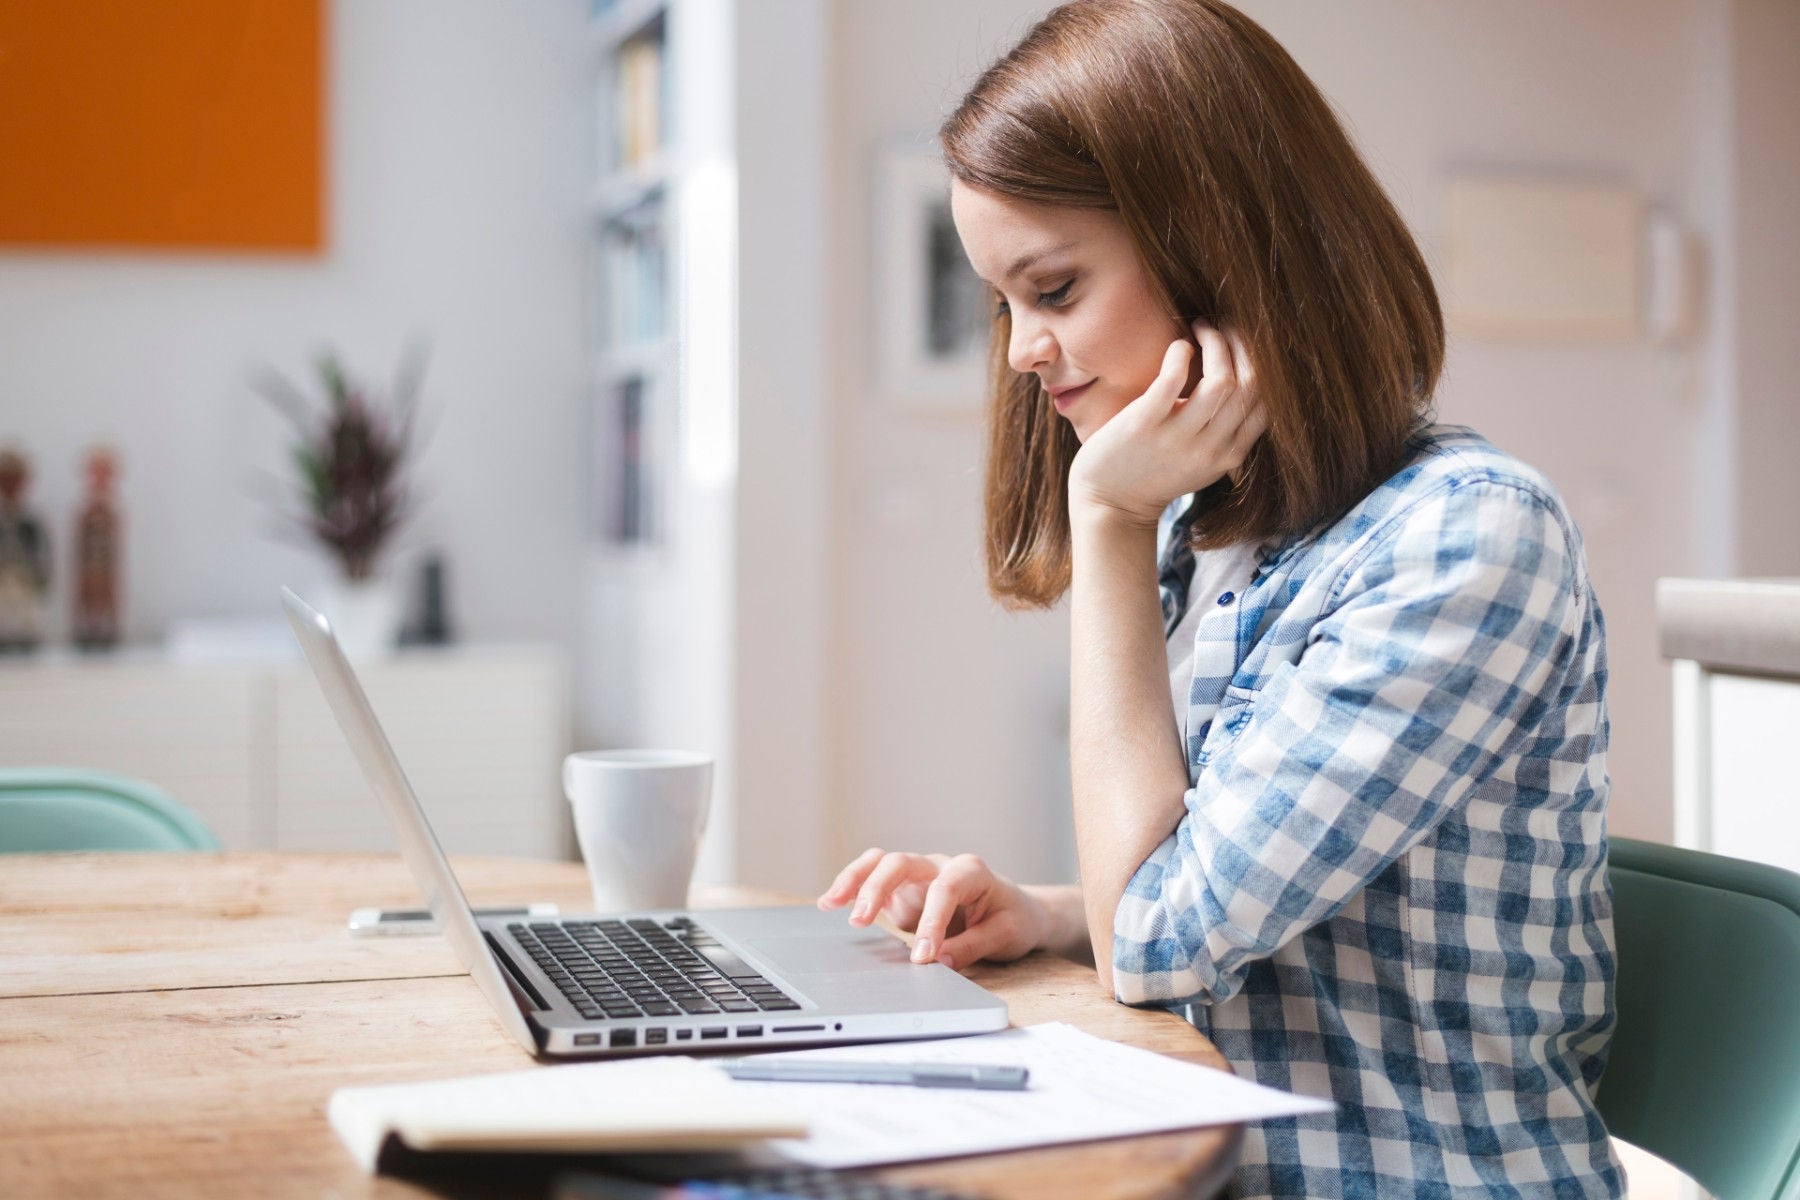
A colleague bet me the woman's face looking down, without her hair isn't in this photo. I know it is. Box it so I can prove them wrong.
[950,182,1186,441]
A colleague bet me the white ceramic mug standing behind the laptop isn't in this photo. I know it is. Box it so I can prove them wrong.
[563,750,713,912]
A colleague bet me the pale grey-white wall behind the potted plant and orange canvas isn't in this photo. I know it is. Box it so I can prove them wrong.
[0,0,590,658]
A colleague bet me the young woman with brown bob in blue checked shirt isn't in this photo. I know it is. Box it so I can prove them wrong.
[819,0,1624,1196]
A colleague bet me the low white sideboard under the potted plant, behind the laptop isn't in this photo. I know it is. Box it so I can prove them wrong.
[0,646,572,858]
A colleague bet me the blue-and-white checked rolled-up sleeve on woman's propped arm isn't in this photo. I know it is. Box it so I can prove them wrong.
[1112,479,1580,1004]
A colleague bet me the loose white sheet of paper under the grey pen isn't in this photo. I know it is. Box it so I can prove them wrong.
[694,1024,1332,1168]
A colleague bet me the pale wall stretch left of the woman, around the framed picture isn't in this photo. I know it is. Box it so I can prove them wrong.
[826,0,1073,878]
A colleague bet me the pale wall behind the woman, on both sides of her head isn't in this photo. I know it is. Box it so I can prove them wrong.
[828,0,1800,876]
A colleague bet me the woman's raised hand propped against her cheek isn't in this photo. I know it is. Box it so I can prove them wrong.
[1069,320,1267,529]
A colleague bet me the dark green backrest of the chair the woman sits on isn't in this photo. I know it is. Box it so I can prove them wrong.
[1595,838,1800,1200]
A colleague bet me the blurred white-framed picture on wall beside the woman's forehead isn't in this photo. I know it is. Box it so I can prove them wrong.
[869,144,994,414]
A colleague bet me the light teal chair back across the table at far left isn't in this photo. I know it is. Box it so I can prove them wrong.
[0,766,220,855]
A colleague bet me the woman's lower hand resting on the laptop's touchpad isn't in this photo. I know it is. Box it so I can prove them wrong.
[819,849,1049,968]
